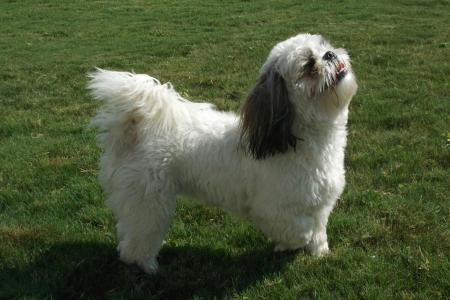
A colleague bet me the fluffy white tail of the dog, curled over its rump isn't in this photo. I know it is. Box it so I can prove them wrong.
[88,69,199,149]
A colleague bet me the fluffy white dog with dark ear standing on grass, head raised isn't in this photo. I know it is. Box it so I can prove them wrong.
[89,34,357,272]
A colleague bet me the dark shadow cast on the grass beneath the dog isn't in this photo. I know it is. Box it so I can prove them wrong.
[0,243,294,299]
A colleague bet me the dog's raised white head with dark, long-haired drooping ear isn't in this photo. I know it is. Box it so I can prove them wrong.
[241,34,357,159]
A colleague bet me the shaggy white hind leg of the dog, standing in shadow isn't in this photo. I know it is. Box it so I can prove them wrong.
[108,166,175,273]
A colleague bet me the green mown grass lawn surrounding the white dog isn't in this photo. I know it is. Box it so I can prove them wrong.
[0,0,450,299]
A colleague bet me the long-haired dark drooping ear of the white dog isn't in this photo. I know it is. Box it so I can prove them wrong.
[241,71,297,159]
